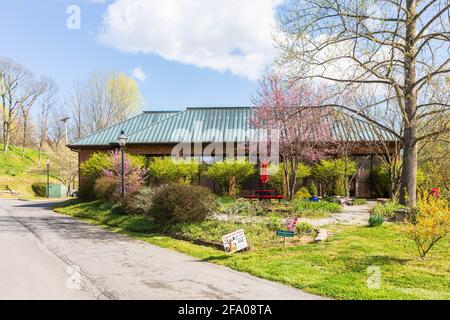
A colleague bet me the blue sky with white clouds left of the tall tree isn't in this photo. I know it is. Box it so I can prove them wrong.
[0,0,282,110]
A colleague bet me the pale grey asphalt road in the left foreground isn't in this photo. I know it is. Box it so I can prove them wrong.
[0,199,320,299]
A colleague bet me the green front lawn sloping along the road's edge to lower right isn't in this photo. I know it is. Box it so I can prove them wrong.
[56,202,450,299]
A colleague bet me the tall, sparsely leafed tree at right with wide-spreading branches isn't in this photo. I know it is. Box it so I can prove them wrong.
[280,0,450,206]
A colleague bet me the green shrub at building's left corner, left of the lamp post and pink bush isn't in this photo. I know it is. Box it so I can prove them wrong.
[78,152,112,201]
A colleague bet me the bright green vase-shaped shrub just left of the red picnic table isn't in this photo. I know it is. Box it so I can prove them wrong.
[206,160,255,197]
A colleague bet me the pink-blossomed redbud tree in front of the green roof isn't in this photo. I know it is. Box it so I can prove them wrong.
[252,74,332,199]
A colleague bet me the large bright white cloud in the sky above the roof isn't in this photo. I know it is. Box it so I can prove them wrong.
[99,0,283,80]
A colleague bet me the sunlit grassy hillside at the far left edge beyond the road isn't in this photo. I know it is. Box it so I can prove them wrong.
[0,144,55,198]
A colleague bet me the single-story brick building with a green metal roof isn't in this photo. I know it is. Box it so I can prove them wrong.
[68,107,395,197]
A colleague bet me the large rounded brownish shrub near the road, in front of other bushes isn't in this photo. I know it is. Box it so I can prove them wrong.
[151,184,217,222]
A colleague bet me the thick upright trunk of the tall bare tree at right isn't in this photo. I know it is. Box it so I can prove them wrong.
[400,0,417,207]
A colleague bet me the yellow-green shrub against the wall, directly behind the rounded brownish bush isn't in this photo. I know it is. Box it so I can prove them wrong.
[148,157,199,184]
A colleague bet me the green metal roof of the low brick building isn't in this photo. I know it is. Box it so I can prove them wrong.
[69,107,395,148]
